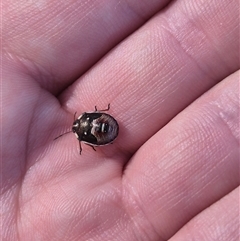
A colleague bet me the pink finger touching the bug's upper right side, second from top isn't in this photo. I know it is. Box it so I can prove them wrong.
[61,1,239,155]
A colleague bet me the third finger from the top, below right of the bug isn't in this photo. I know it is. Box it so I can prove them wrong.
[123,73,240,240]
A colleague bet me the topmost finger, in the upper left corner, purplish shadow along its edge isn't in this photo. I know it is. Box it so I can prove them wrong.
[3,0,169,92]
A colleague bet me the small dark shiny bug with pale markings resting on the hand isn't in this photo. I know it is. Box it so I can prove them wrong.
[54,104,119,155]
